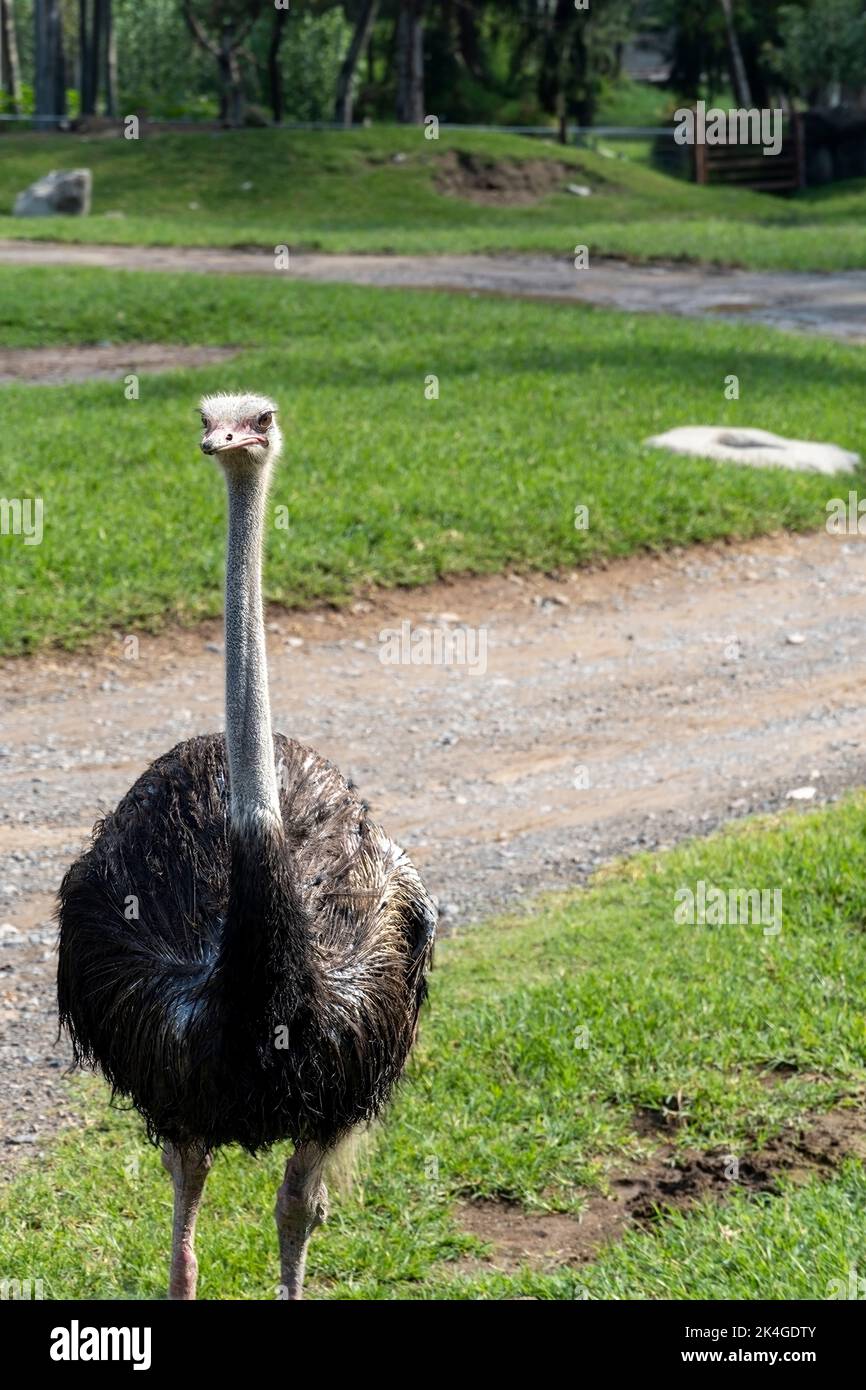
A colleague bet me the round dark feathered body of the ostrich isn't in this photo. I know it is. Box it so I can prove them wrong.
[58,734,435,1152]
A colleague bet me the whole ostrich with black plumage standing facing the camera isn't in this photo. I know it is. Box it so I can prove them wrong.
[58,395,436,1298]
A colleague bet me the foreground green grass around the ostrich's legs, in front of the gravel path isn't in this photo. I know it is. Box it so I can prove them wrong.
[0,796,866,1298]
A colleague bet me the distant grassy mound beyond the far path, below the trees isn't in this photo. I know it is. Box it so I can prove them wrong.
[0,126,866,270]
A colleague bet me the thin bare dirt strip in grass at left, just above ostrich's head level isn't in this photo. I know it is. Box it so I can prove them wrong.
[0,343,238,386]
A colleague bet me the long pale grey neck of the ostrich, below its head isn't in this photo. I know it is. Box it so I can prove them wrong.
[225,468,281,828]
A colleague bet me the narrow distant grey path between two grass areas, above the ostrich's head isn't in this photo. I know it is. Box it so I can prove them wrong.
[0,240,866,342]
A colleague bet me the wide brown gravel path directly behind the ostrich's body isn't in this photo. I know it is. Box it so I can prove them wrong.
[0,532,866,1170]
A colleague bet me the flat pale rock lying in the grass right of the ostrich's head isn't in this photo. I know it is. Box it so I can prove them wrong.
[644,425,860,473]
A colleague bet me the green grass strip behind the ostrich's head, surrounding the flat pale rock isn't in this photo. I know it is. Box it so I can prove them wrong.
[0,268,866,652]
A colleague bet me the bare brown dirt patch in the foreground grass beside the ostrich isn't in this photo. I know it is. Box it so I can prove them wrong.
[449,1102,866,1275]
